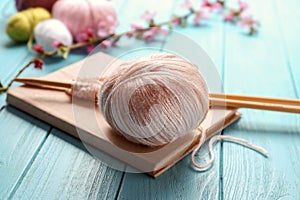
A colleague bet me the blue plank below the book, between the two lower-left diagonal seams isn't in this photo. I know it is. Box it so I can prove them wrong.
[13,129,122,200]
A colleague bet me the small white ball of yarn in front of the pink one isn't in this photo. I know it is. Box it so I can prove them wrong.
[34,19,73,51]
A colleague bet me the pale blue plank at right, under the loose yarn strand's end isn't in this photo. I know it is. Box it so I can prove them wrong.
[222,0,300,199]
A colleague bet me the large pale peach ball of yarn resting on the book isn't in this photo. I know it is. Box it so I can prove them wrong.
[99,53,209,146]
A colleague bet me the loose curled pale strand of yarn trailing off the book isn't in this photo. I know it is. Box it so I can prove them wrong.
[191,131,268,171]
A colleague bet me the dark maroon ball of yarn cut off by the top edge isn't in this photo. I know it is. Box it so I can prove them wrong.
[16,0,57,11]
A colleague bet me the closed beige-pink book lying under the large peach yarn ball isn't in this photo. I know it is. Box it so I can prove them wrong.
[7,53,240,177]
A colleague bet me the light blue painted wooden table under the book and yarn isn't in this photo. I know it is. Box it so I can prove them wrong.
[0,0,300,200]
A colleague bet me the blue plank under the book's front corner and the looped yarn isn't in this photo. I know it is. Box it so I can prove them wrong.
[119,1,223,199]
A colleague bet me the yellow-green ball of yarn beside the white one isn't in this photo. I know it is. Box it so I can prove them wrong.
[6,8,51,42]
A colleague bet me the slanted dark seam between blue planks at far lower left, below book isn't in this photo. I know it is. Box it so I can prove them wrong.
[8,127,53,199]
